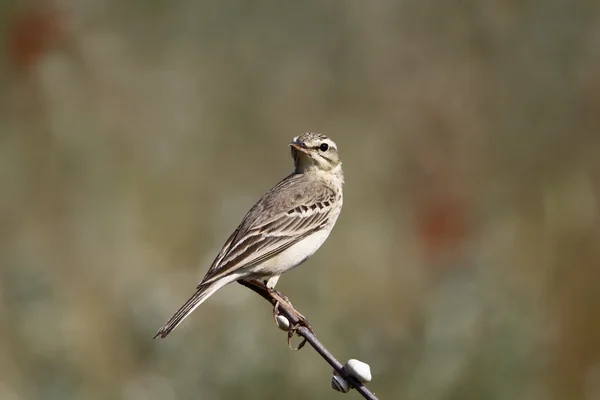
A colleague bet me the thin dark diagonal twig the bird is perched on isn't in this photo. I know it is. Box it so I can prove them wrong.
[238,281,378,400]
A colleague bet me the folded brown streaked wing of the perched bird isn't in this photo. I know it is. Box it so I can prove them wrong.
[200,175,336,285]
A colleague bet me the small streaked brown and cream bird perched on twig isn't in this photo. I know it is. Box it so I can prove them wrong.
[154,132,344,338]
